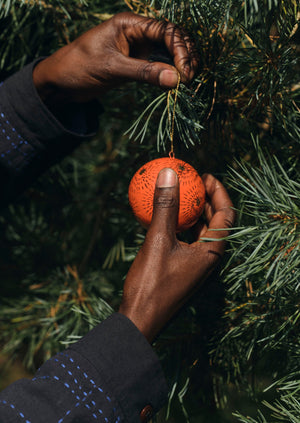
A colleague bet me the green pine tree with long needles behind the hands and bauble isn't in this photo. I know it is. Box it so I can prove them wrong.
[0,0,300,423]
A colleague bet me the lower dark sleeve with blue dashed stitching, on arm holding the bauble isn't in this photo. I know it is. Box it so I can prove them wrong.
[0,313,167,423]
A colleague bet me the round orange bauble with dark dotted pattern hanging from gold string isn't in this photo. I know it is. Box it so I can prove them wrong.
[128,157,205,232]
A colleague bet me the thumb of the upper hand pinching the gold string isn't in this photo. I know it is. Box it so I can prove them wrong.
[114,56,178,89]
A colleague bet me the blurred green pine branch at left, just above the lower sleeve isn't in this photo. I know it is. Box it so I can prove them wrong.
[0,267,114,369]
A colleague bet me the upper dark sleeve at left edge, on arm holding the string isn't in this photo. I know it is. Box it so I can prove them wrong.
[0,61,100,206]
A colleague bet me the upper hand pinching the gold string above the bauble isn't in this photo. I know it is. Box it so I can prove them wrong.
[33,12,198,104]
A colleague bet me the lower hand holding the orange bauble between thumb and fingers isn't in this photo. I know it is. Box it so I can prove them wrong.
[119,169,234,342]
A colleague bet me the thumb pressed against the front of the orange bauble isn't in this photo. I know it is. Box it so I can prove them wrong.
[149,168,179,236]
